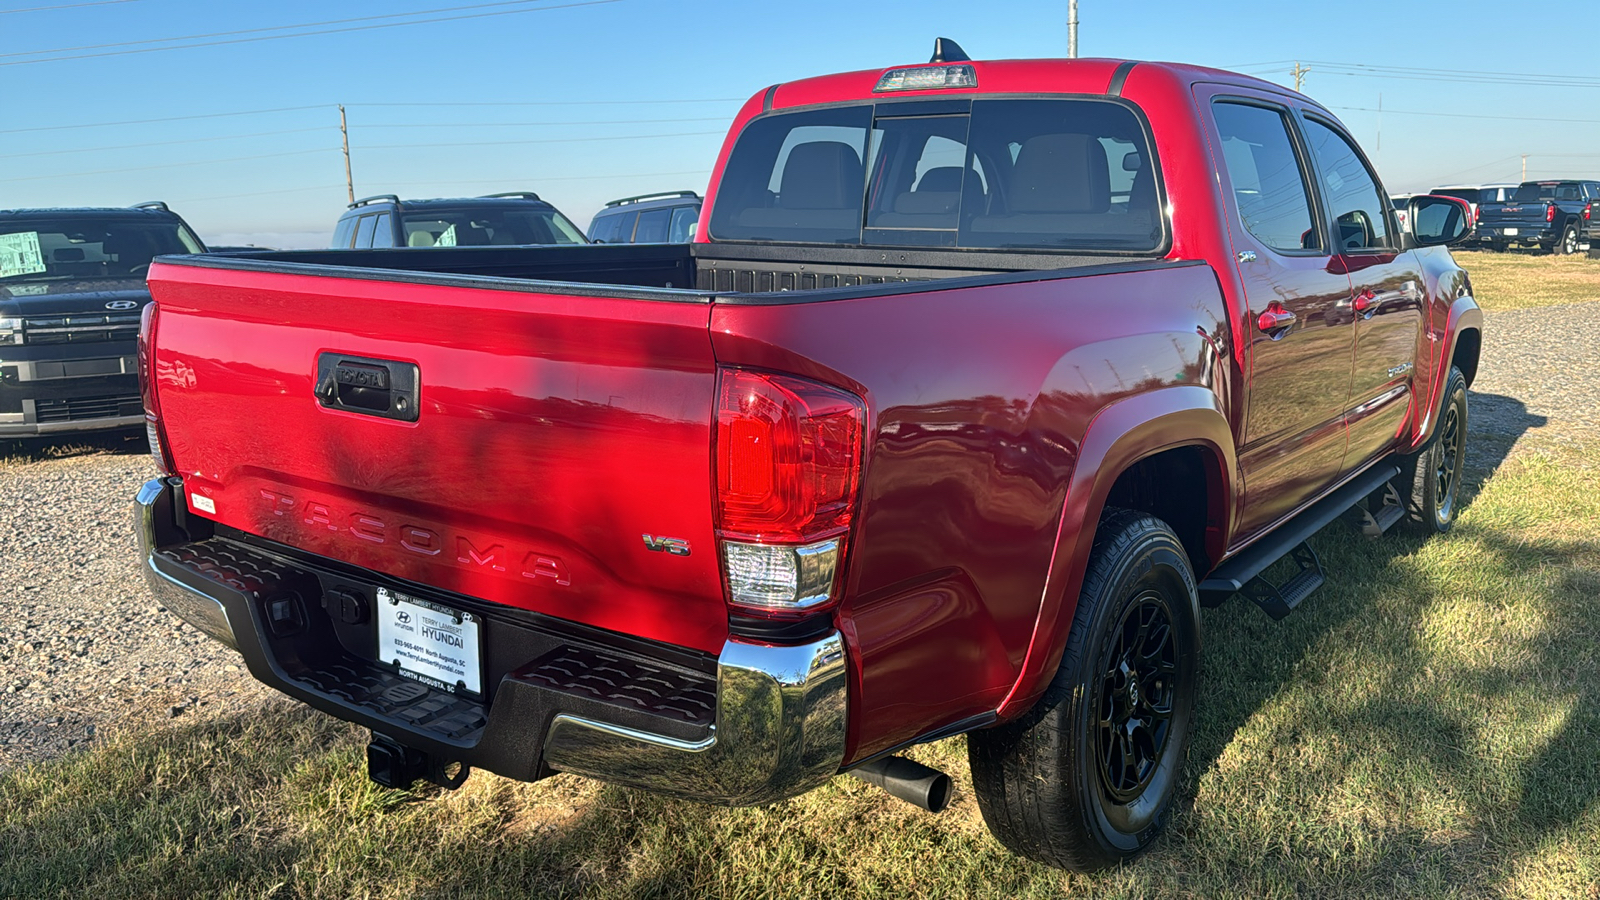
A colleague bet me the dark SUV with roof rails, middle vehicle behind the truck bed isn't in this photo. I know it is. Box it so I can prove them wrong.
[330,191,589,250]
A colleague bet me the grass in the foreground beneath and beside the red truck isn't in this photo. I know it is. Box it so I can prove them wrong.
[0,452,1600,900]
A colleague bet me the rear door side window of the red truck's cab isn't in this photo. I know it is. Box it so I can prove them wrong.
[1211,102,1322,251]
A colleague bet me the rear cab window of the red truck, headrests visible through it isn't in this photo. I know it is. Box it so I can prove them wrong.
[710,99,1166,253]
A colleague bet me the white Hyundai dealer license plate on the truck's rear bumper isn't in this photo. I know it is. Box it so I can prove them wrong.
[378,588,483,693]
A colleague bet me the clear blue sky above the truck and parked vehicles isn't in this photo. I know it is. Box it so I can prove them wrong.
[0,0,1600,247]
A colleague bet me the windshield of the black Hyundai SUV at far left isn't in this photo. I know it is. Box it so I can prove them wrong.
[0,218,205,283]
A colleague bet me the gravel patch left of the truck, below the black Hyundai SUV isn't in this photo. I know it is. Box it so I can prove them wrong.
[0,440,272,770]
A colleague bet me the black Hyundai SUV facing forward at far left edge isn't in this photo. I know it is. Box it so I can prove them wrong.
[0,202,206,437]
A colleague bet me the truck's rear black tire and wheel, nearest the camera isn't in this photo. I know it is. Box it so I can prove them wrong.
[966,509,1200,871]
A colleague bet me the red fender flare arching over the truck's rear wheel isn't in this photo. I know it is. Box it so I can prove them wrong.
[997,384,1243,719]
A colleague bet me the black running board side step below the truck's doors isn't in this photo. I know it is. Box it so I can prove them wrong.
[1200,460,1400,608]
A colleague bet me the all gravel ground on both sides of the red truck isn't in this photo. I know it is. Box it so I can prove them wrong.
[0,303,1600,770]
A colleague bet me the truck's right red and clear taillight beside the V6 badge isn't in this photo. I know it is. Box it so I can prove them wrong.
[717,368,866,615]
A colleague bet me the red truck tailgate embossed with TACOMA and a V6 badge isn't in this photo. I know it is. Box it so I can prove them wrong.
[150,263,728,652]
